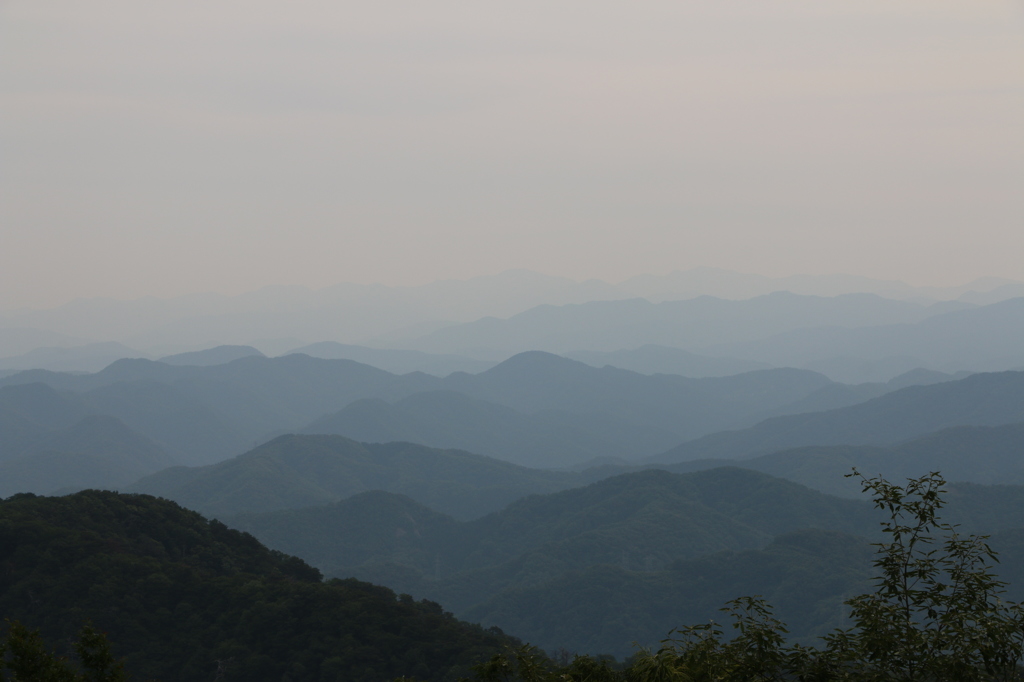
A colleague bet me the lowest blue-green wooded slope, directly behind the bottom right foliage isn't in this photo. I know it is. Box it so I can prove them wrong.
[465,522,871,657]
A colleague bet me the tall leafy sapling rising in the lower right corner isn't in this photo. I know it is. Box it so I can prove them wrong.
[826,473,1024,681]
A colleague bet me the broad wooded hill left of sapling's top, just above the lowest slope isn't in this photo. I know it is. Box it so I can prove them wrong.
[448,468,873,568]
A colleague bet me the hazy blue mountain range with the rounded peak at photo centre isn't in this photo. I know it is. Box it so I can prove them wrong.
[0,352,856,466]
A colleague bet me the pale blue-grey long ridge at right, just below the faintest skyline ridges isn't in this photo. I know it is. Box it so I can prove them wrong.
[397,293,1024,383]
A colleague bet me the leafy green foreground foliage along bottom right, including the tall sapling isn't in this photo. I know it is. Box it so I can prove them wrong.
[466,466,1024,682]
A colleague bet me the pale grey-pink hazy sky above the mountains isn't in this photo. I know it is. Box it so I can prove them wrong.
[0,0,1024,307]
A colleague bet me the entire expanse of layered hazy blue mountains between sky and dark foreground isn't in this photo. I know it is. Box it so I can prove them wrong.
[6,271,1024,656]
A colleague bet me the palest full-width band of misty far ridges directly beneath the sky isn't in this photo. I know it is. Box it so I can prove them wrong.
[0,268,1024,383]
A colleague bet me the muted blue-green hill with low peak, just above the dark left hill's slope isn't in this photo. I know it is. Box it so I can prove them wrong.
[131,435,582,518]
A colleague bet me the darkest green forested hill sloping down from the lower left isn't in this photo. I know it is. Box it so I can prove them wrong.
[0,491,508,682]
